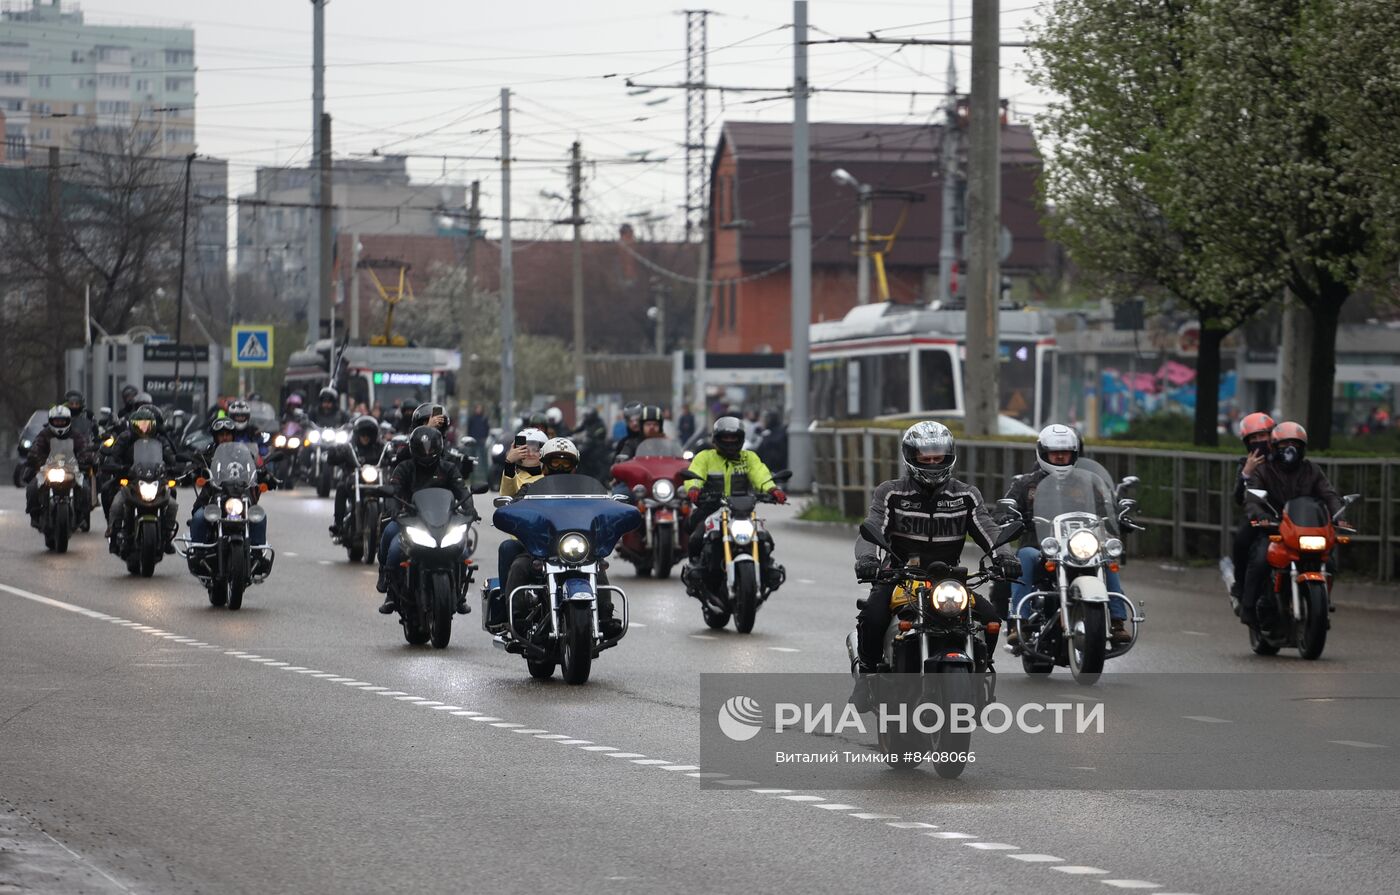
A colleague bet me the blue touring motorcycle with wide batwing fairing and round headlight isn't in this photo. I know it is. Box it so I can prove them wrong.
[482,475,641,685]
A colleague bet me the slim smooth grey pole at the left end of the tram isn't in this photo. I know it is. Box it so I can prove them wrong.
[788,0,812,493]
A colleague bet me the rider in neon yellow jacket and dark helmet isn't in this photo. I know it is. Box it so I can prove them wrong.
[680,416,787,597]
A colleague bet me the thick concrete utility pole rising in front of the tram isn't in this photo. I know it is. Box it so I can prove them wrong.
[963,0,1001,436]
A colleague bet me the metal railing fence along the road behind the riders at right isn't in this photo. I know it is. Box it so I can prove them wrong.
[812,429,1400,581]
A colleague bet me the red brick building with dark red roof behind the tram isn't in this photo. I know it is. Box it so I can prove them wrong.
[706,122,1057,353]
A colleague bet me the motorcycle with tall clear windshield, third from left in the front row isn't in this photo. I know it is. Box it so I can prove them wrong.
[175,441,276,609]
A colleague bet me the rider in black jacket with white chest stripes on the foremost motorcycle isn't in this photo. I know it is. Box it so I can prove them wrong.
[845,420,1021,712]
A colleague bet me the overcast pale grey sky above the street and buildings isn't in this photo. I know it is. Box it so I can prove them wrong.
[80,0,1044,238]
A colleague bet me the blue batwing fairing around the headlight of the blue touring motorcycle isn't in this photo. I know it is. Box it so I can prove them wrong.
[493,493,641,559]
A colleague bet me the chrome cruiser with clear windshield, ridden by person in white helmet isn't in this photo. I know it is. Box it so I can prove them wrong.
[1004,461,1147,685]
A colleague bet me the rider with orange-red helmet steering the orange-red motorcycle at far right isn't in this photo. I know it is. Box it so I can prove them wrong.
[1239,422,1347,626]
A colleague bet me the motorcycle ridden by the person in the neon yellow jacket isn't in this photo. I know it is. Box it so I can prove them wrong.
[685,471,792,634]
